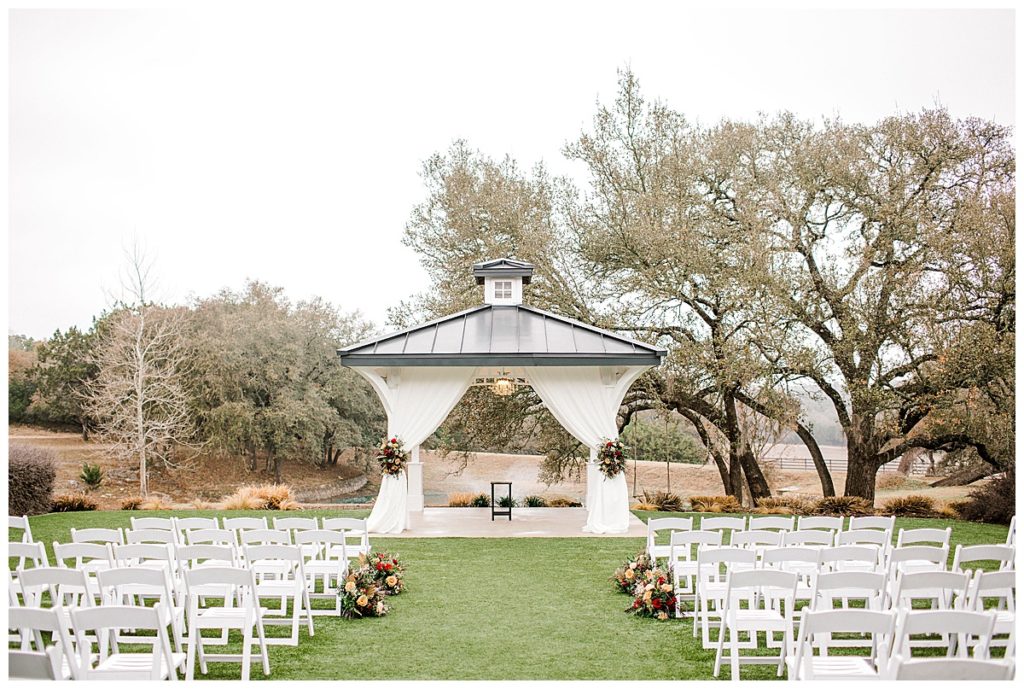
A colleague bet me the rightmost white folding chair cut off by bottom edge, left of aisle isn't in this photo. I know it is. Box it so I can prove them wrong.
[71,604,185,680]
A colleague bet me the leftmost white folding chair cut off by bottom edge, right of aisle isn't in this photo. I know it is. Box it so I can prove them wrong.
[786,606,896,681]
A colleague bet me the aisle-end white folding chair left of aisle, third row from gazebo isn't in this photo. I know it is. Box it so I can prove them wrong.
[244,545,313,646]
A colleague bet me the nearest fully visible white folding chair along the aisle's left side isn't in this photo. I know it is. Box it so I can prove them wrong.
[184,565,270,681]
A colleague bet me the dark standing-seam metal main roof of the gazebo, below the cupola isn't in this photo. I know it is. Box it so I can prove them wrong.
[338,300,666,367]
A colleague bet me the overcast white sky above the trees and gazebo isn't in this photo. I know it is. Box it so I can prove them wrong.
[8,2,1015,337]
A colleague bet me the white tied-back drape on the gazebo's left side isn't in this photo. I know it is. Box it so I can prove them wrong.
[353,367,476,533]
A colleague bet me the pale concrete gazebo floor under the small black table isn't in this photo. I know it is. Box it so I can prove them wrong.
[387,507,647,539]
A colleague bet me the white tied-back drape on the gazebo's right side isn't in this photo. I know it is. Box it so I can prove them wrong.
[526,367,650,533]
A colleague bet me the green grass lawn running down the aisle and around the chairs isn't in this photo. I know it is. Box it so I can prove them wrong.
[11,511,1007,680]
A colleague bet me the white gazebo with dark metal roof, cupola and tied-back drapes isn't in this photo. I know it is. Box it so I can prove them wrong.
[338,258,666,533]
